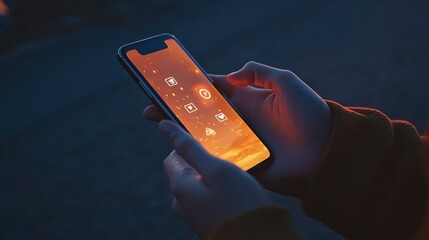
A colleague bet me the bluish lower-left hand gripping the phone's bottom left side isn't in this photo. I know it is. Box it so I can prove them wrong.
[159,120,271,237]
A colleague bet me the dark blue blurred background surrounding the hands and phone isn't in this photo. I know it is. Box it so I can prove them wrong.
[0,0,429,239]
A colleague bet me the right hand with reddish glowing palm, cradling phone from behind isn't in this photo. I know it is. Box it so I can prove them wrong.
[144,62,331,197]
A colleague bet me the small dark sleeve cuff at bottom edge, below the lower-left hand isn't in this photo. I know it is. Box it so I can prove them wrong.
[208,206,300,240]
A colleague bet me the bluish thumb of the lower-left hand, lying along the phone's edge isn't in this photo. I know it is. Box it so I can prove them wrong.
[159,120,220,176]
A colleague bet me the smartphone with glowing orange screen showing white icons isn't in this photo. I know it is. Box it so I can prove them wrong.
[118,34,270,171]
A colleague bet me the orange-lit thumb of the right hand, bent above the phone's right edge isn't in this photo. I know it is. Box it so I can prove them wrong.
[227,61,304,93]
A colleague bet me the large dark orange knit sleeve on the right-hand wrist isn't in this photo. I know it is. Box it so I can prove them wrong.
[303,101,429,239]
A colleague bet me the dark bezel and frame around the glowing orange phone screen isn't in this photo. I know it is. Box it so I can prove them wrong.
[117,33,272,171]
